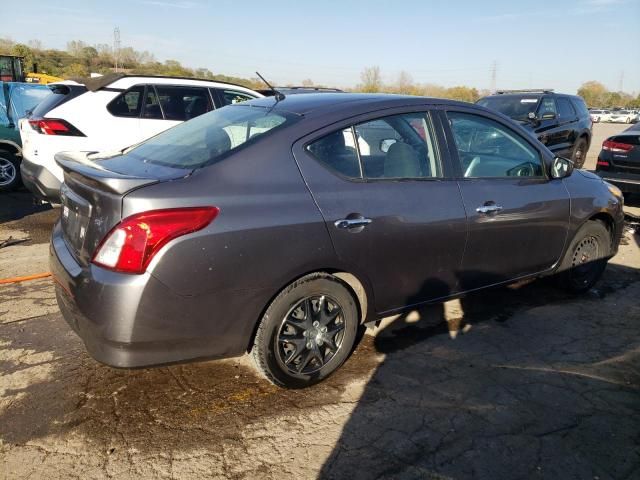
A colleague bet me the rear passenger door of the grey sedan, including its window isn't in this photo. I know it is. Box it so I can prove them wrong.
[294,109,466,313]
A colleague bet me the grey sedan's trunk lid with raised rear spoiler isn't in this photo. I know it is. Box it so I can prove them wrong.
[55,152,190,266]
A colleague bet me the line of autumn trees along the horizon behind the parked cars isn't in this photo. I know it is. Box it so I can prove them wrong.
[0,37,640,108]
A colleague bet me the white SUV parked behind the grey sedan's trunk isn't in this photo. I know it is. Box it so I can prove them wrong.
[20,74,263,203]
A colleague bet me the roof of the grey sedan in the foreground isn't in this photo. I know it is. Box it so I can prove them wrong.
[238,93,475,116]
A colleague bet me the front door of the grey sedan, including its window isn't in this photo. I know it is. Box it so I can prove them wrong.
[443,109,570,290]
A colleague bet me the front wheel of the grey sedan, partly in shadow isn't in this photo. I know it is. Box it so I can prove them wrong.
[557,220,611,293]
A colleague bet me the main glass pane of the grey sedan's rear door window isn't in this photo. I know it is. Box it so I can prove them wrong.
[355,112,441,179]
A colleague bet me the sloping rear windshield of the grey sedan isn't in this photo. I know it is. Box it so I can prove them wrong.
[124,105,300,169]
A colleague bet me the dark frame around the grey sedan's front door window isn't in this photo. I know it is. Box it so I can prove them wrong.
[441,107,551,181]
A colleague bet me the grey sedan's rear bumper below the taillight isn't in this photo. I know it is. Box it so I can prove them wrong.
[50,223,265,368]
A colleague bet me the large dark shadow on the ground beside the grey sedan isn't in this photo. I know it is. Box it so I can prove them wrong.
[320,260,640,480]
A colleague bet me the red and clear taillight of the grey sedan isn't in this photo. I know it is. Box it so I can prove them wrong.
[92,207,220,274]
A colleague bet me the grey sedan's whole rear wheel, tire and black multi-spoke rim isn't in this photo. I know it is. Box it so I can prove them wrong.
[251,273,360,388]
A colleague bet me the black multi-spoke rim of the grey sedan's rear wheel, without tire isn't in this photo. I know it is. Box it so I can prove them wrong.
[276,295,345,375]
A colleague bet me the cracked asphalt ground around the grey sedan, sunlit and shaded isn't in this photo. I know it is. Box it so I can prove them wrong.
[0,156,640,480]
